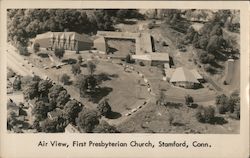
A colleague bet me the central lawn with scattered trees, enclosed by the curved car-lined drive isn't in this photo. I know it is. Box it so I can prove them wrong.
[25,52,149,113]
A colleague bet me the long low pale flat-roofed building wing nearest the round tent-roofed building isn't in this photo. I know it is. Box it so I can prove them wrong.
[132,52,170,67]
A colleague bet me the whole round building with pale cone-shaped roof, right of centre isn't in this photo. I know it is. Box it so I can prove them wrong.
[170,67,200,89]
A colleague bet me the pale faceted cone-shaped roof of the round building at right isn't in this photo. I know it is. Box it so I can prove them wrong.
[170,67,200,83]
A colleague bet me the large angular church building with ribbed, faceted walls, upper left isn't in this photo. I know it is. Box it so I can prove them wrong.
[34,32,93,51]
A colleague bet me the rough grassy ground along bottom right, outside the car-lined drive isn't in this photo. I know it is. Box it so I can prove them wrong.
[118,102,240,134]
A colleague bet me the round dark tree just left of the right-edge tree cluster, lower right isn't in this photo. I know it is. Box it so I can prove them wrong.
[196,105,215,123]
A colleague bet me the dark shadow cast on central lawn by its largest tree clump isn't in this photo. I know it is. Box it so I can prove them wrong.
[91,87,113,103]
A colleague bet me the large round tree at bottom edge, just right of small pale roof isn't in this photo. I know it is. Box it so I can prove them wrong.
[76,109,99,133]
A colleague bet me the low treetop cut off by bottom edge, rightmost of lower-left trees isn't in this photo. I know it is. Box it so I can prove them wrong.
[93,121,119,133]
